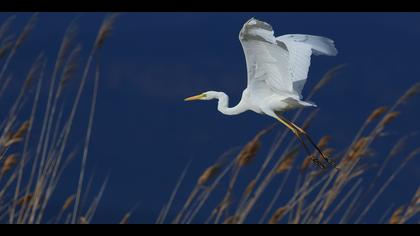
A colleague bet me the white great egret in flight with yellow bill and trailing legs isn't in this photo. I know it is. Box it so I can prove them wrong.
[185,18,337,168]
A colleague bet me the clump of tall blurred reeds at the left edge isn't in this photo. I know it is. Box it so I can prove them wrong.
[0,14,116,224]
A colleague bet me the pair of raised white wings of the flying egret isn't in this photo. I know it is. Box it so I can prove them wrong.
[239,18,337,97]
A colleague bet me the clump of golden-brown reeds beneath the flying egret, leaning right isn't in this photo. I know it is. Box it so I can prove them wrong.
[158,65,420,224]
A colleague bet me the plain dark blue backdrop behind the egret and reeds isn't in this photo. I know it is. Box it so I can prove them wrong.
[0,13,420,222]
